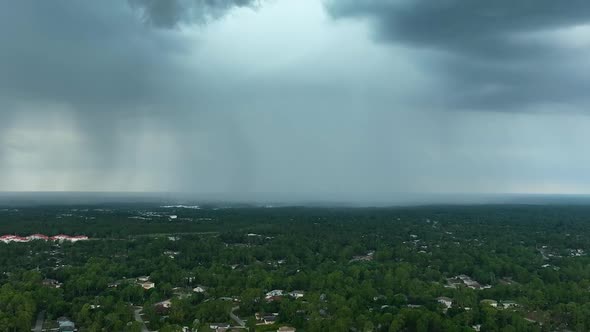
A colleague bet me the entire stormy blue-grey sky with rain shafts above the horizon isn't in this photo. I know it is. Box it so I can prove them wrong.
[0,0,590,200]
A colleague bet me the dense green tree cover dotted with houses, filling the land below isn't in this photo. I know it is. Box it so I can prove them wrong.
[0,205,590,331]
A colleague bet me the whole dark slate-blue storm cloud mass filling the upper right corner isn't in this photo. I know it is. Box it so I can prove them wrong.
[327,0,590,111]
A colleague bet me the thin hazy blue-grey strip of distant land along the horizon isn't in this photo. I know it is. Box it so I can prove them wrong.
[0,191,590,208]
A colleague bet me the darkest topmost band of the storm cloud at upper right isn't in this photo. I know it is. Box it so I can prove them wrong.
[328,0,590,57]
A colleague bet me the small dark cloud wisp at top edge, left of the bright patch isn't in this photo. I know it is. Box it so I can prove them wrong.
[129,0,258,28]
